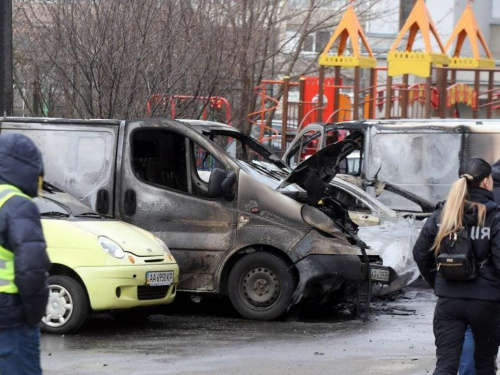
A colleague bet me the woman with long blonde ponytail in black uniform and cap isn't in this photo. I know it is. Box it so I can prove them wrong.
[413,158,500,375]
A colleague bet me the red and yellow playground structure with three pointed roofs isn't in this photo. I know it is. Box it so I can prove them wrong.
[247,0,500,151]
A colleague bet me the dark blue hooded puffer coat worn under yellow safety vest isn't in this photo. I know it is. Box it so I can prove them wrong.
[0,134,50,330]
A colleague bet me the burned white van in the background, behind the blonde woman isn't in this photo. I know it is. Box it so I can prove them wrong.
[283,119,500,211]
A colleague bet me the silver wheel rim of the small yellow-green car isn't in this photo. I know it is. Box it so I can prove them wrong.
[42,285,74,327]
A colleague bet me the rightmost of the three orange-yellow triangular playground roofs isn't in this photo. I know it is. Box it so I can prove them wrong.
[445,1,495,67]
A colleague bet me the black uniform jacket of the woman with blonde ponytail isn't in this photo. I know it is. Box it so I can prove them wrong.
[413,188,500,301]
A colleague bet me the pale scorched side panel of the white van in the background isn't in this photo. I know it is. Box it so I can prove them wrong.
[365,126,463,206]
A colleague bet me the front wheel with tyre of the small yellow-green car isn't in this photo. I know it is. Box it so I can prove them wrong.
[41,275,89,333]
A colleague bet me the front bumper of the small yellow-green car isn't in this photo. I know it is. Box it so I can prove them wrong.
[75,264,179,310]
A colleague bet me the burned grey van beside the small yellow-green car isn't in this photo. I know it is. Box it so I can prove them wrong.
[0,118,397,320]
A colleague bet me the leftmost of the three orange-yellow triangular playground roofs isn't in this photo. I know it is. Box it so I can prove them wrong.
[319,1,376,68]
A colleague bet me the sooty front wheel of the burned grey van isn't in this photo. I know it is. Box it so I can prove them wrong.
[228,252,296,320]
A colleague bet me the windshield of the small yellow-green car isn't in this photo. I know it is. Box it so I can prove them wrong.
[33,182,99,217]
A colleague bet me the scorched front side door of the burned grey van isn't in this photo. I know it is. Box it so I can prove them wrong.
[116,120,236,291]
